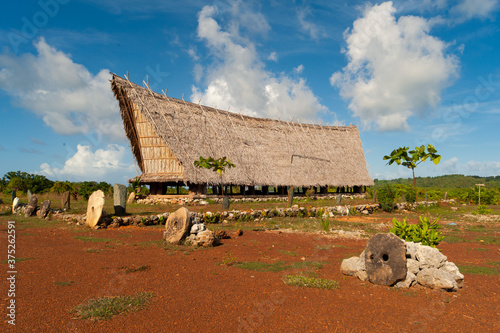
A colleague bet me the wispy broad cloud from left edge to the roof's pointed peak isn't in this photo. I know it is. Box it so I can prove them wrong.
[0,38,125,139]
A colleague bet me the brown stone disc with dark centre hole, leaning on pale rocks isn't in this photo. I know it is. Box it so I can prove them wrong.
[365,233,406,286]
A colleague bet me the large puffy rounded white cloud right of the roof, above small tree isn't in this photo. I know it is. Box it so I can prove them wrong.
[330,2,458,131]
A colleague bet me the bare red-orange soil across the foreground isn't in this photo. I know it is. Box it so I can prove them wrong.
[0,219,500,333]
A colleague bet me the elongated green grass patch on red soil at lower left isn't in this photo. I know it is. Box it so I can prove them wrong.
[71,293,153,320]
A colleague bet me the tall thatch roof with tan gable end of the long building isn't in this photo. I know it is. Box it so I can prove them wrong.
[111,75,373,186]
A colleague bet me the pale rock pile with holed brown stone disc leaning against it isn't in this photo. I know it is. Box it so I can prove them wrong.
[340,234,464,291]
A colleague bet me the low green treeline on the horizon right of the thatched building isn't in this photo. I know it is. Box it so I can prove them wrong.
[374,175,500,189]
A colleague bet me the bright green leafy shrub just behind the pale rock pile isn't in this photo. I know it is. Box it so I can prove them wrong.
[389,216,444,247]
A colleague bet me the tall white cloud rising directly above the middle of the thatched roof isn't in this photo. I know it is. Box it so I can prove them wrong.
[191,6,327,120]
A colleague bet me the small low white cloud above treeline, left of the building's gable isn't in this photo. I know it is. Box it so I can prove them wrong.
[36,144,137,182]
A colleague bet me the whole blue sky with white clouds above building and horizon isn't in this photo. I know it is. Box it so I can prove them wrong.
[0,0,500,183]
